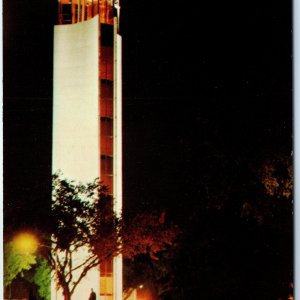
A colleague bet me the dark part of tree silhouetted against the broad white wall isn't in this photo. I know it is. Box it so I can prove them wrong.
[50,175,98,299]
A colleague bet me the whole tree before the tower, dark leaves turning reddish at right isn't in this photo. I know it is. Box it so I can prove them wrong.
[50,174,178,300]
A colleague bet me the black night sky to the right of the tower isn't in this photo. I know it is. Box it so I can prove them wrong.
[121,1,292,213]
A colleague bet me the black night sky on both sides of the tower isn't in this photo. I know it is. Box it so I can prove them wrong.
[3,0,292,226]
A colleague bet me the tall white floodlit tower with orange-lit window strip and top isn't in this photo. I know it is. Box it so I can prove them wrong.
[51,0,122,300]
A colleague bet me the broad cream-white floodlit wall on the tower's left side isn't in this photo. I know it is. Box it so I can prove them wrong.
[51,16,100,300]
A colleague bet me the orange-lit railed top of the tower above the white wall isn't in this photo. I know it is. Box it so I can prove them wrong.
[58,0,120,25]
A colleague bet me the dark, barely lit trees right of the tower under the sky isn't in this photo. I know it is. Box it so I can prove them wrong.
[124,154,293,300]
